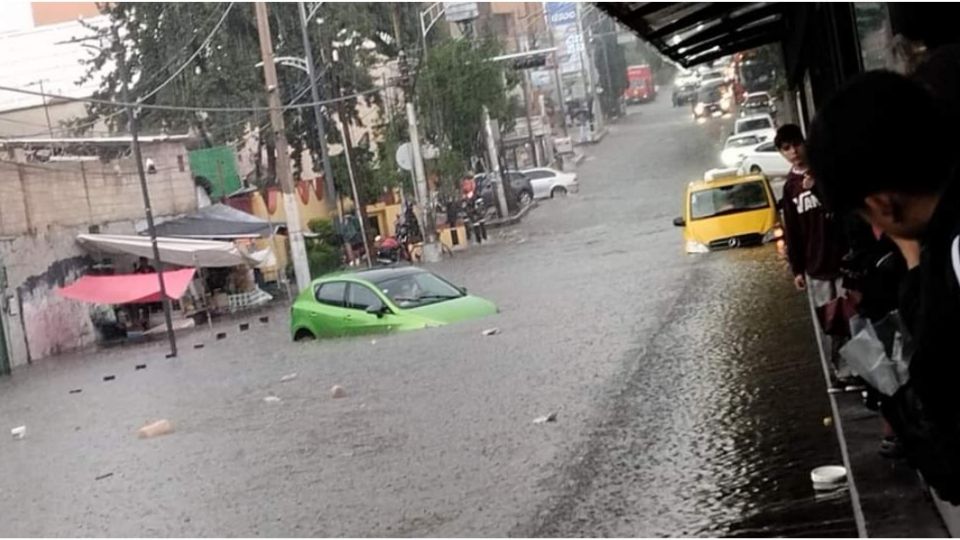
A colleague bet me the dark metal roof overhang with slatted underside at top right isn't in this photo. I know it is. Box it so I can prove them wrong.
[596,2,784,67]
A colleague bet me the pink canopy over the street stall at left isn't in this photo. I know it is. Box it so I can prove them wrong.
[57,268,196,304]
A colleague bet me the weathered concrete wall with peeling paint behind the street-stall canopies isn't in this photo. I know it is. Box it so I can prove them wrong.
[0,143,197,366]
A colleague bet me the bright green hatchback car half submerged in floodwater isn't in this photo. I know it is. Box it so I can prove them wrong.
[290,266,497,341]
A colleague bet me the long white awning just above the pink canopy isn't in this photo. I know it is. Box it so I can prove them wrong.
[77,234,276,268]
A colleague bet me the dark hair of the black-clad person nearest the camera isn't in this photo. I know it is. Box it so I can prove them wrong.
[807,71,957,212]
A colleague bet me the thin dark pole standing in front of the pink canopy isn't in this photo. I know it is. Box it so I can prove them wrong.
[111,25,177,358]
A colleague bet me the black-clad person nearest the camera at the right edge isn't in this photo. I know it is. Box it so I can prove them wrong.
[808,71,960,504]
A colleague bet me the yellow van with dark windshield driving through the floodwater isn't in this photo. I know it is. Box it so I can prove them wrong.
[673,169,783,253]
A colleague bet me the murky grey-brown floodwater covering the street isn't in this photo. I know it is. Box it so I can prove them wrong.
[0,100,855,536]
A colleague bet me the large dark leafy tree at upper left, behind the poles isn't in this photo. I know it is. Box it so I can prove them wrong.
[71,2,419,193]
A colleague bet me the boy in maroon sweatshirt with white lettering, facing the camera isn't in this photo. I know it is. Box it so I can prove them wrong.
[774,124,850,387]
